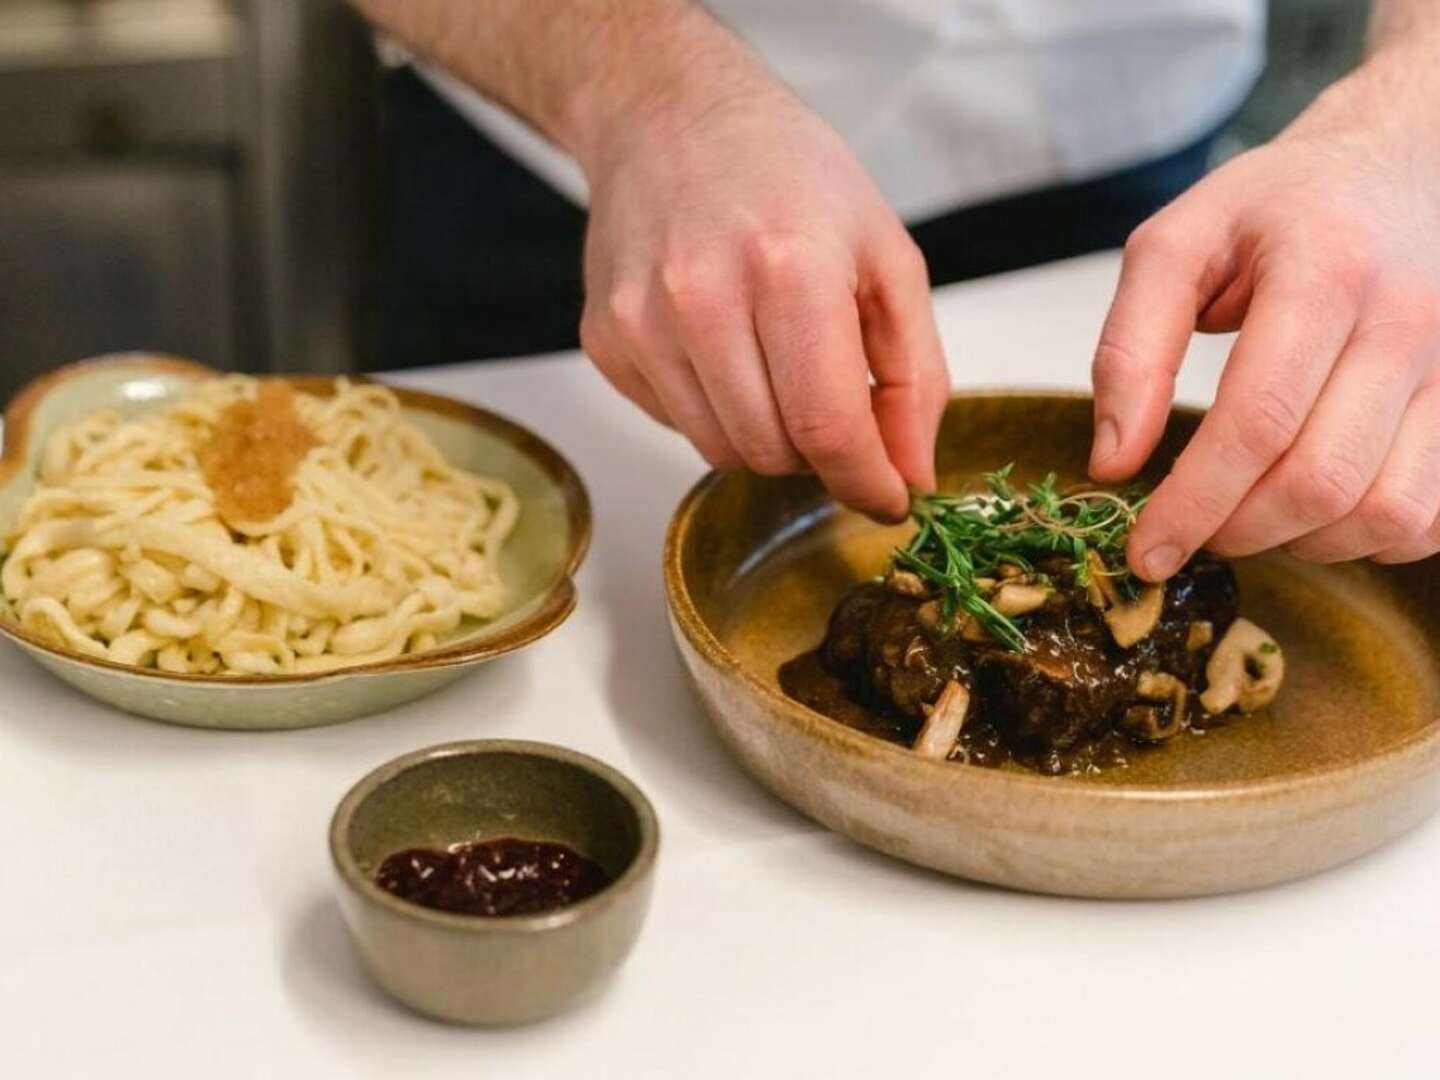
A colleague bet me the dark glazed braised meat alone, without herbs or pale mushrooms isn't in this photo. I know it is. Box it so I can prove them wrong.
[782,554,1238,773]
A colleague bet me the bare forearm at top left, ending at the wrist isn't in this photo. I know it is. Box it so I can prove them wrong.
[351,0,762,171]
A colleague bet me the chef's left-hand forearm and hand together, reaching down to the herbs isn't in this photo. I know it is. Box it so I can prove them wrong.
[351,0,949,520]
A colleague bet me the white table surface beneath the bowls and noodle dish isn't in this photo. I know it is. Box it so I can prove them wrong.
[0,255,1440,1080]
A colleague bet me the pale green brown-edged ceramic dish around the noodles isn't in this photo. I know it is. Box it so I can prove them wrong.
[0,360,590,729]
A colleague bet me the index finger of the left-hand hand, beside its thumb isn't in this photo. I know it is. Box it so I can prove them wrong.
[755,244,910,520]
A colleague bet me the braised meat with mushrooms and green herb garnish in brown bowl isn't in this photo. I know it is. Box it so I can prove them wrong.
[779,465,1284,775]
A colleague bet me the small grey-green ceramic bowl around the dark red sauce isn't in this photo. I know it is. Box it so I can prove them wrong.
[330,739,660,1024]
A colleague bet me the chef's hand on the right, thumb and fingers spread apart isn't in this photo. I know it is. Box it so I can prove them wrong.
[1092,36,1440,580]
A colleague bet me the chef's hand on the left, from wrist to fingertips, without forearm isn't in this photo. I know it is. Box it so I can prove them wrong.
[567,65,949,518]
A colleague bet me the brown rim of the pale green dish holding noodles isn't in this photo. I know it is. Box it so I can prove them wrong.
[0,360,592,687]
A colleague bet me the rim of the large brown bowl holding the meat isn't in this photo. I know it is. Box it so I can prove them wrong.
[662,387,1440,805]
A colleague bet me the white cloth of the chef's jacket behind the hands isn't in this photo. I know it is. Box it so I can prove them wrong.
[420,0,1264,220]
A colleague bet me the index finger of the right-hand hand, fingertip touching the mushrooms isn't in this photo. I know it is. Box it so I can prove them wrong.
[1129,276,1354,582]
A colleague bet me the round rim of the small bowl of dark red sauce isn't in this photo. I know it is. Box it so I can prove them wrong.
[330,739,660,935]
